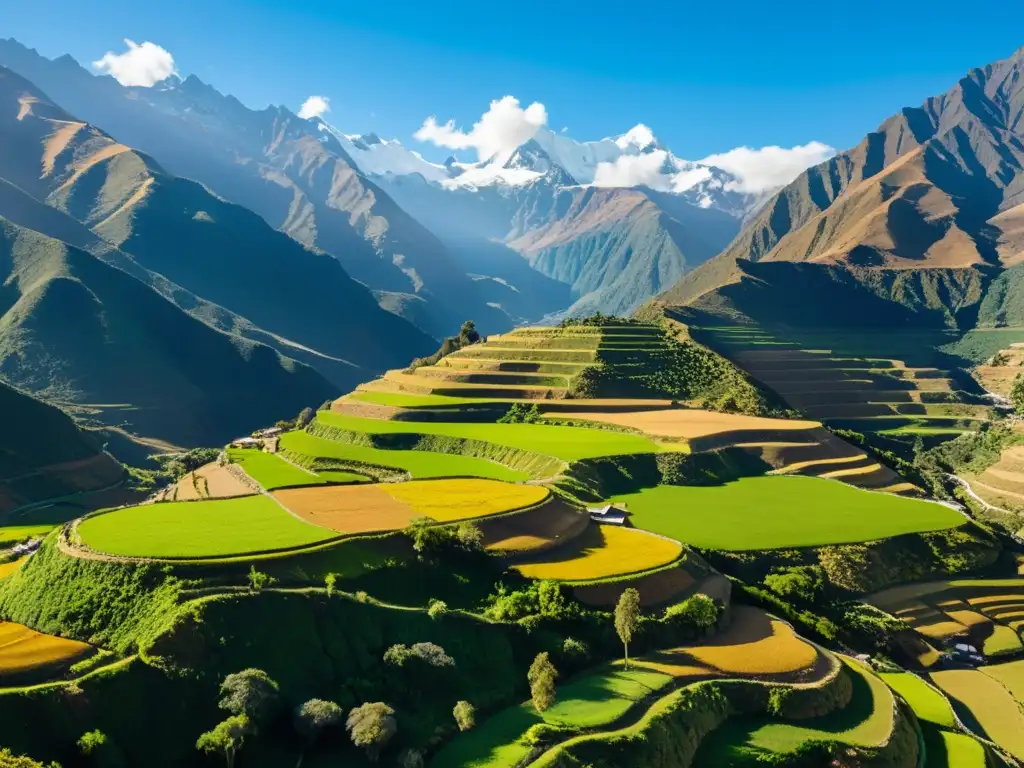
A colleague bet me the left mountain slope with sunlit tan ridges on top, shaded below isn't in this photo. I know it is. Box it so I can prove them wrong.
[0,70,434,386]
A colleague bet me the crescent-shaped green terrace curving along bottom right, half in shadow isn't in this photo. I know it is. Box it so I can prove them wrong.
[693,659,894,766]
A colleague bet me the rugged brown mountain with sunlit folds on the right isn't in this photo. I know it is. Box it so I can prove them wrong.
[663,49,1024,325]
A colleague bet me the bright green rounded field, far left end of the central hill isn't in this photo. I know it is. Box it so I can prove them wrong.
[78,496,337,557]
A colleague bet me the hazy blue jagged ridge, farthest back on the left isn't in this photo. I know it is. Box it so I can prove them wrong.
[0,40,520,337]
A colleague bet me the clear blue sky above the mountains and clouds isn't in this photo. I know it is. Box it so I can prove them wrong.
[0,0,1024,159]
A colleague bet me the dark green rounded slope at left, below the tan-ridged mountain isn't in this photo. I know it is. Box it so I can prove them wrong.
[0,219,335,445]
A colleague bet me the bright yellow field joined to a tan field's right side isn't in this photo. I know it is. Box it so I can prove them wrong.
[381,478,551,522]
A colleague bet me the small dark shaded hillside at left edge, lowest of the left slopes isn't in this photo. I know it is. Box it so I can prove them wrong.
[0,381,125,514]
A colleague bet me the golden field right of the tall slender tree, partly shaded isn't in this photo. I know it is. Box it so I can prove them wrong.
[680,605,818,675]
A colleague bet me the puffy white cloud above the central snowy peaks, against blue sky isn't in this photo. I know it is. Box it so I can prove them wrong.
[414,96,548,160]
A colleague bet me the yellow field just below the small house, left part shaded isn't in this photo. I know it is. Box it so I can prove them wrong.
[515,525,683,582]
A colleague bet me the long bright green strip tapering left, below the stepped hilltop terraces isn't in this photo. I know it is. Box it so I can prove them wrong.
[316,412,662,461]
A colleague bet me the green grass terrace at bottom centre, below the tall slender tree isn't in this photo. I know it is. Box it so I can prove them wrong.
[430,667,672,768]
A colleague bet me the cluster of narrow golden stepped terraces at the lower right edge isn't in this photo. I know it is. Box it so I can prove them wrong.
[866,579,1024,656]
